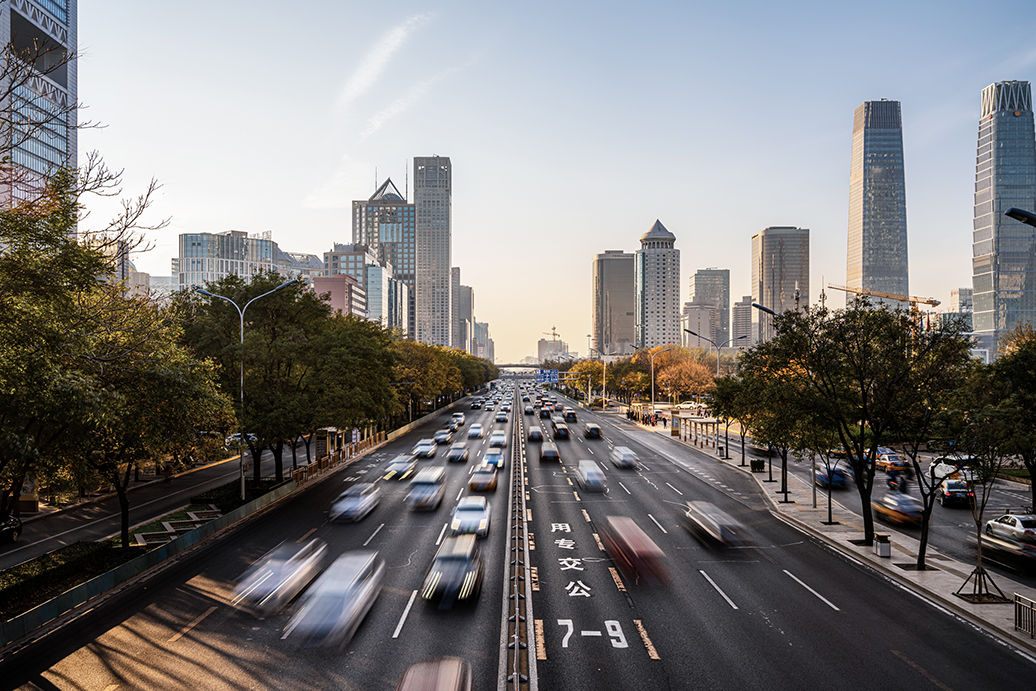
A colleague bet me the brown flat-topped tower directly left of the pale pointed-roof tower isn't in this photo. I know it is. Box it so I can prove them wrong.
[591,250,636,355]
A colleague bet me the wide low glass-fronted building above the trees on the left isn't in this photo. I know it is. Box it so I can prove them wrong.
[172,230,280,290]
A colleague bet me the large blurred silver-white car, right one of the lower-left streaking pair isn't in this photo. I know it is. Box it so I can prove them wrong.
[285,550,385,645]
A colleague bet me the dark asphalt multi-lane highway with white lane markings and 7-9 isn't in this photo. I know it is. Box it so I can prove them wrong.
[0,387,1036,691]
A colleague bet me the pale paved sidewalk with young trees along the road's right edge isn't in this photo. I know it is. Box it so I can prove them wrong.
[618,413,1036,654]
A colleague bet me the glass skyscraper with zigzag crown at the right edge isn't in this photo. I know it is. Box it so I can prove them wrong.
[972,82,1036,353]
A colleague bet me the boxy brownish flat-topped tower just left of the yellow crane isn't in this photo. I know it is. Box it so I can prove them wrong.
[752,226,809,343]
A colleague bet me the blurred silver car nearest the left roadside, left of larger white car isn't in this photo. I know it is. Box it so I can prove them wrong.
[231,540,327,616]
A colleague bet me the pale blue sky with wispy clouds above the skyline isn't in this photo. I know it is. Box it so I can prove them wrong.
[79,0,1036,362]
